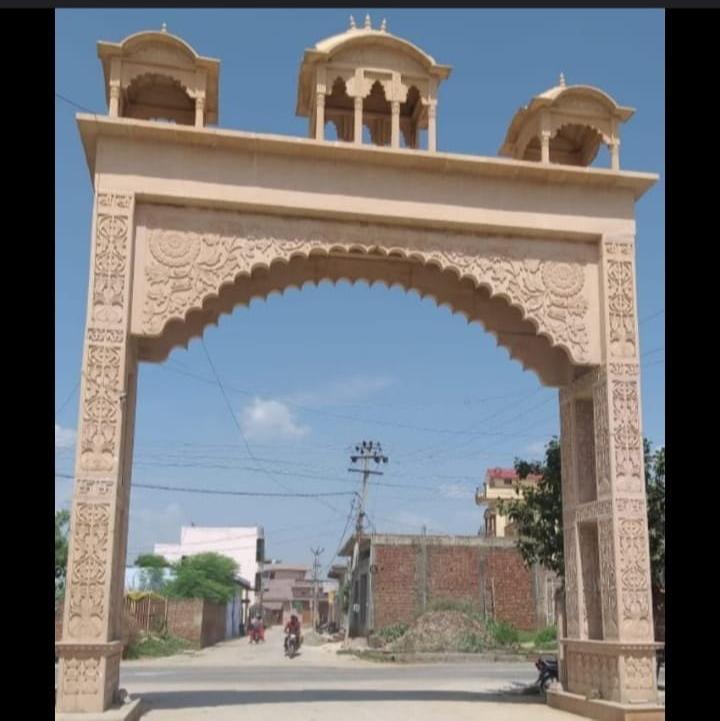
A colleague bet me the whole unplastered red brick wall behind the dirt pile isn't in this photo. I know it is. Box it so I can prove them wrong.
[372,541,542,630]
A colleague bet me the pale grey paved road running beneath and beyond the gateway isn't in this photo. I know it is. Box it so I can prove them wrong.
[54,629,664,721]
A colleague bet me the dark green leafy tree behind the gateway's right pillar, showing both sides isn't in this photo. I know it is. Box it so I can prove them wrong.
[498,438,665,596]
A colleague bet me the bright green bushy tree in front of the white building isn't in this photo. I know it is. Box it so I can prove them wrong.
[164,553,238,603]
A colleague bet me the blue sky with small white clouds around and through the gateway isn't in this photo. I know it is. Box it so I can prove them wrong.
[55,8,665,564]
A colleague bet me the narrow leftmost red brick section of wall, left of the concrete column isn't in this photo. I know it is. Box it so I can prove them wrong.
[372,545,416,629]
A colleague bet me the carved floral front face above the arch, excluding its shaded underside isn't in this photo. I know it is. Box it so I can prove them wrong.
[138,207,591,363]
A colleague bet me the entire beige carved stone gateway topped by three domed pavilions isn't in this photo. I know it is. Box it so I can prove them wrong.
[56,17,664,721]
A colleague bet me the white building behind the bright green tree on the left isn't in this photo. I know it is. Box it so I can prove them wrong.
[154,526,265,603]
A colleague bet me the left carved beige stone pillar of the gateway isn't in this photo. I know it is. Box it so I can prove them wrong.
[56,190,137,712]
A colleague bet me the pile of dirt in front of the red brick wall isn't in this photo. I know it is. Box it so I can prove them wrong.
[386,611,488,653]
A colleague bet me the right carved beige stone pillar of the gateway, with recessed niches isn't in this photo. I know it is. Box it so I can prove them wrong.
[561,236,658,704]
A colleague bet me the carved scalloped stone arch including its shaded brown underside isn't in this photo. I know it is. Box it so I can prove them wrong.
[133,206,599,384]
